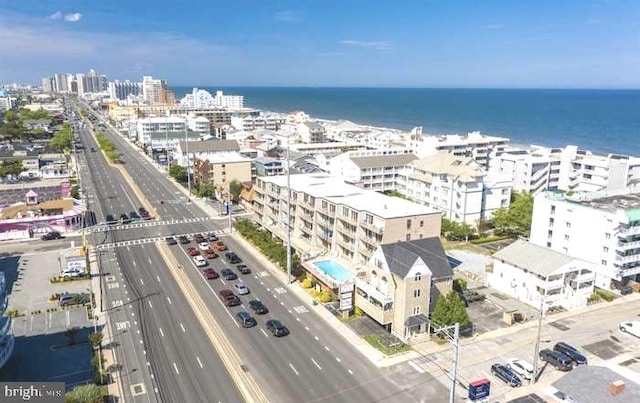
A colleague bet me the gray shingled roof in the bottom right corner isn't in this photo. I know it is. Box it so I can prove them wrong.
[553,365,640,403]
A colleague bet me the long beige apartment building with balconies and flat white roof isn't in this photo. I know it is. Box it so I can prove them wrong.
[253,174,441,267]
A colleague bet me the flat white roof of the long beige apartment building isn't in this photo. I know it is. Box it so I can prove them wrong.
[261,174,440,219]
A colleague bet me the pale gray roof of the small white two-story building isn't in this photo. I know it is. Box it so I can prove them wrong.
[493,240,576,276]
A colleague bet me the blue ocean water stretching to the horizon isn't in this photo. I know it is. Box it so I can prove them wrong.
[173,87,640,156]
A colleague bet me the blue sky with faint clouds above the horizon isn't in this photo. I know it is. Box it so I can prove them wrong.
[0,0,640,88]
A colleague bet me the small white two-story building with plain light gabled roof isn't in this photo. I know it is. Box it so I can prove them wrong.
[487,240,596,309]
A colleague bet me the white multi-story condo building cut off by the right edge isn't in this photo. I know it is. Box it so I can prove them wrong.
[530,191,640,289]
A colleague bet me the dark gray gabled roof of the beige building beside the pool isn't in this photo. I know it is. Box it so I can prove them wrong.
[381,237,453,279]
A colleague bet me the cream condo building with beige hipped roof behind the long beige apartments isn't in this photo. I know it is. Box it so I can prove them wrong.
[396,153,512,226]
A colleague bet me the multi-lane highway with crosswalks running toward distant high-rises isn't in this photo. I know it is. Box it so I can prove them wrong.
[72,100,442,402]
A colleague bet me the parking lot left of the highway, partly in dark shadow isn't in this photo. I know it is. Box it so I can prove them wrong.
[0,239,95,387]
